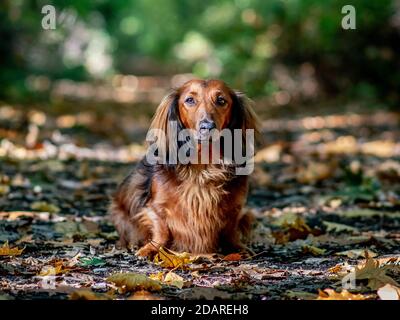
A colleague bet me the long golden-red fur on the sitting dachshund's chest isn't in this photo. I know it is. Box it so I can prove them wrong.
[156,166,238,252]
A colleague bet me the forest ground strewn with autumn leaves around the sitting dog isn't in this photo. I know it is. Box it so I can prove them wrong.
[0,104,400,300]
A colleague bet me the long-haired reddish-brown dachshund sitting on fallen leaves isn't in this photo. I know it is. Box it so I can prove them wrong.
[110,80,258,257]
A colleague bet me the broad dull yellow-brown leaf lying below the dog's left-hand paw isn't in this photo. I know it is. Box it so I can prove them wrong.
[107,272,161,291]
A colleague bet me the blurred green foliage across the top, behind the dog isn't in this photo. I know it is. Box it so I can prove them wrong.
[0,0,400,103]
